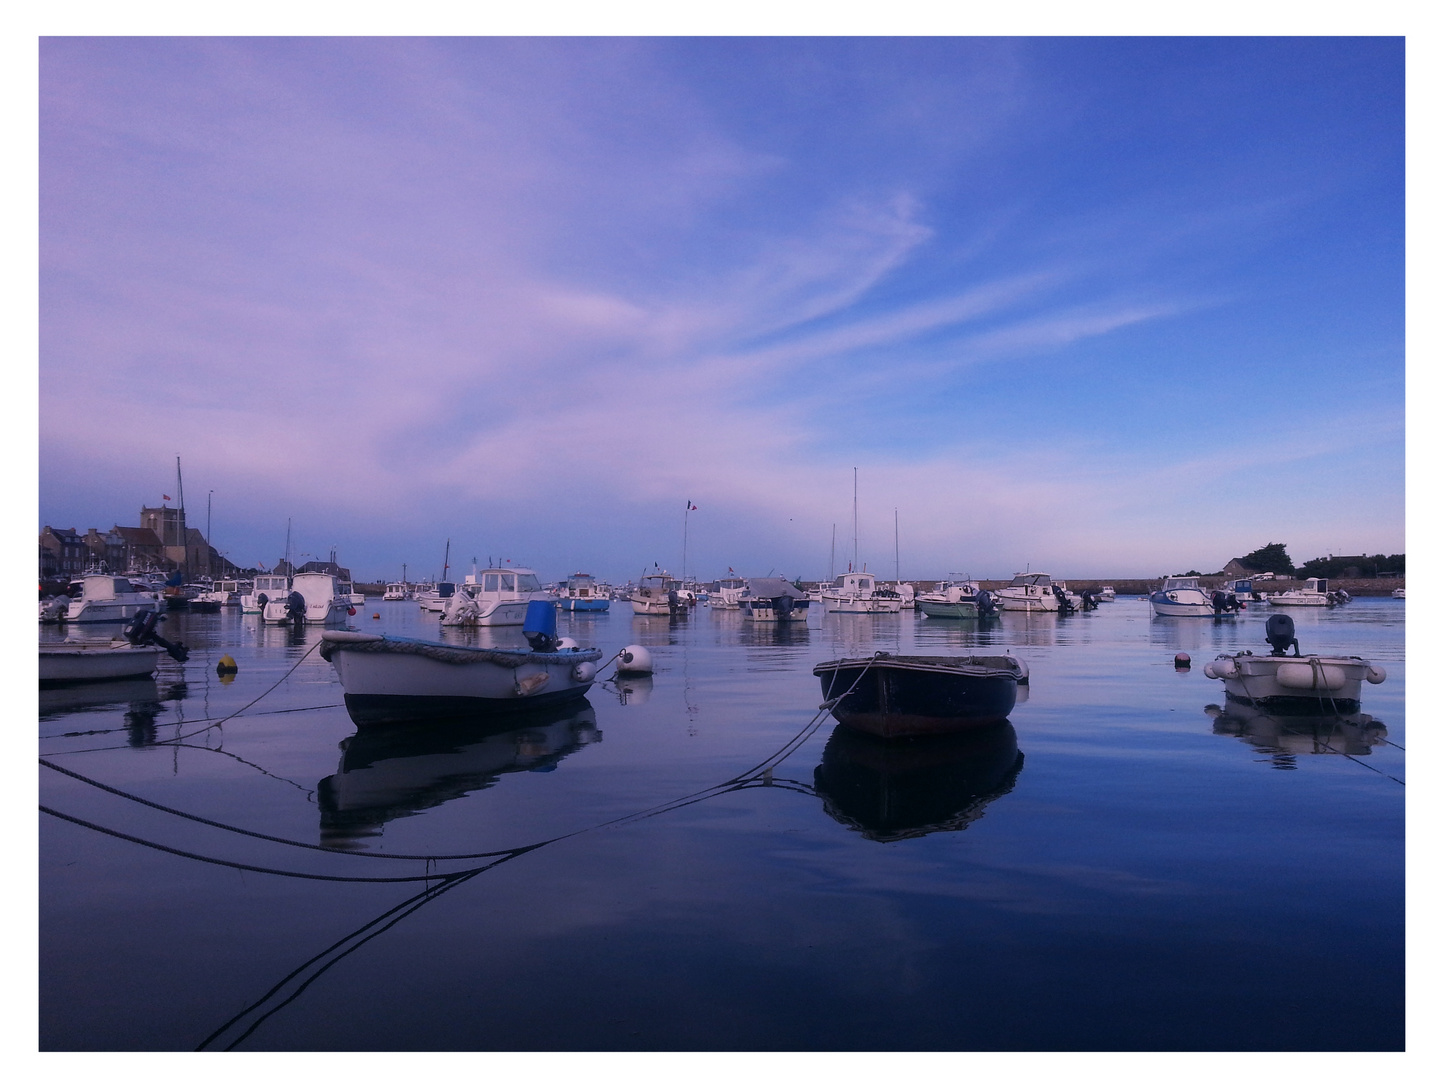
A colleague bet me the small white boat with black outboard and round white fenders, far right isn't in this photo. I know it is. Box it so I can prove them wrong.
[1205,615,1385,714]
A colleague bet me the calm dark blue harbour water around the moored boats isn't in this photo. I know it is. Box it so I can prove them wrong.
[39,598,1405,1050]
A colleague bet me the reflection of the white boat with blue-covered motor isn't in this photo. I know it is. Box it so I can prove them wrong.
[317,701,600,847]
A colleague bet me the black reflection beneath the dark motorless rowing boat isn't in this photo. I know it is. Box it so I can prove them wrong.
[815,720,1025,844]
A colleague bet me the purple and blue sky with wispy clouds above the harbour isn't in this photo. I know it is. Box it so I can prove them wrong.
[37,37,1405,582]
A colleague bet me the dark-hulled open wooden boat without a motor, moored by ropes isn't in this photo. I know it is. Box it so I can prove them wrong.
[815,652,1028,739]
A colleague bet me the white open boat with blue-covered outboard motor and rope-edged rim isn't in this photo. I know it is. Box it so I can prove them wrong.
[320,600,602,726]
